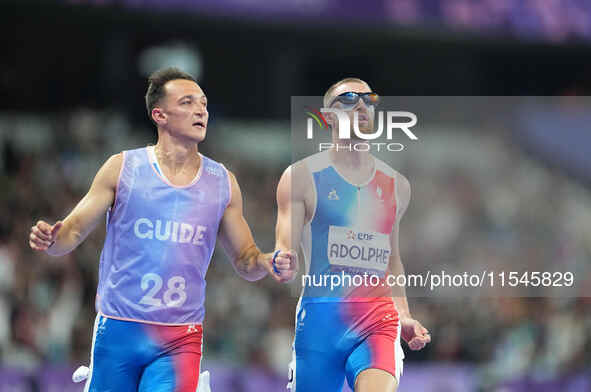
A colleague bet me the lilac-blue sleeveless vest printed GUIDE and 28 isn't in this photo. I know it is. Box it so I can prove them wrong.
[96,147,231,325]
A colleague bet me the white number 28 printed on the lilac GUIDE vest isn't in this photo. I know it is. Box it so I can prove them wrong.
[140,272,187,308]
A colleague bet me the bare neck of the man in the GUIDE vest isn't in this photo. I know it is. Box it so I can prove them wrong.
[154,131,201,173]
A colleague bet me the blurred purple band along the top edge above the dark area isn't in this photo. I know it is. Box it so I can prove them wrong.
[69,0,591,42]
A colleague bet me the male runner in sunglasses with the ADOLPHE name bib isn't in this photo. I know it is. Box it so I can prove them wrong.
[276,78,431,392]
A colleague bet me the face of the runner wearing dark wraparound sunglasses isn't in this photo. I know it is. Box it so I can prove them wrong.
[328,82,375,135]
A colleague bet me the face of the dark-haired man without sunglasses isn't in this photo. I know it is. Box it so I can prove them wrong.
[158,79,209,143]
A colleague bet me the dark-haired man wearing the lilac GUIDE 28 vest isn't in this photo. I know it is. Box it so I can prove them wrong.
[29,68,295,392]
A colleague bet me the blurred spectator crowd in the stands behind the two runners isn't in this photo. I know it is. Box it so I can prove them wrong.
[0,109,591,392]
